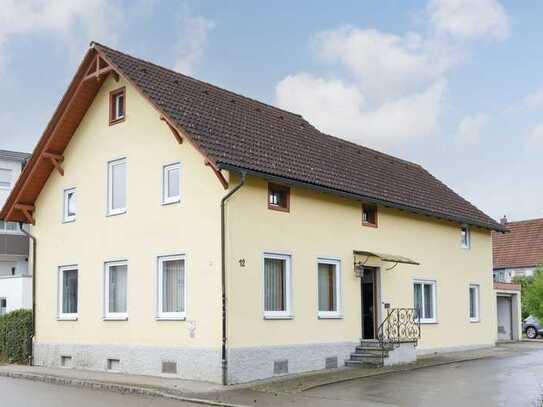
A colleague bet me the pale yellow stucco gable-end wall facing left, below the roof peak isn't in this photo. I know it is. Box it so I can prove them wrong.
[33,78,225,348]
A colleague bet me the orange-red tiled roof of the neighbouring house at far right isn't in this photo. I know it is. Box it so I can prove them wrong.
[492,218,543,269]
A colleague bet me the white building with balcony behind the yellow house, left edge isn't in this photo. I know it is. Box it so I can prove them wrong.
[0,150,32,315]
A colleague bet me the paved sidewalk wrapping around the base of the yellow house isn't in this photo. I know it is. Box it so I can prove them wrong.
[0,343,524,407]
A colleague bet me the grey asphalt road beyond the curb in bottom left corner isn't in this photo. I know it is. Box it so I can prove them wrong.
[0,377,200,407]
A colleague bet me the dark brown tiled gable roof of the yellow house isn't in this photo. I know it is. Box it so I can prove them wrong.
[0,43,505,231]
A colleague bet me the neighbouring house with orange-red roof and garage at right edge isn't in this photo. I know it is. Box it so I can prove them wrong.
[492,216,543,340]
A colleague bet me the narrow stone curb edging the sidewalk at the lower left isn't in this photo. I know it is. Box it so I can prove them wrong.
[0,371,248,407]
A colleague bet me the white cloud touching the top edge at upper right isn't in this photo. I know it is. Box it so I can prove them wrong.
[428,0,510,40]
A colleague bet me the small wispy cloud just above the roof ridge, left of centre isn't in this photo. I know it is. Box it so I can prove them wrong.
[175,7,215,75]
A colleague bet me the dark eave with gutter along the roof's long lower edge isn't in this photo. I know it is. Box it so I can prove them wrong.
[217,160,509,233]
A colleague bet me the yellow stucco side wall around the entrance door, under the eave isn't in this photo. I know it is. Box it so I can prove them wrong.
[228,177,496,349]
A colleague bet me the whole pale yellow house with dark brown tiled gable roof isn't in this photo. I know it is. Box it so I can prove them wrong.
[0,43,505,383]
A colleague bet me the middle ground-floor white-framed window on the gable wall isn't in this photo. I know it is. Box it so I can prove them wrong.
[104,261,128,320]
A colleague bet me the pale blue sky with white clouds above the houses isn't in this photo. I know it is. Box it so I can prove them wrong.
[0,0,543,220]
